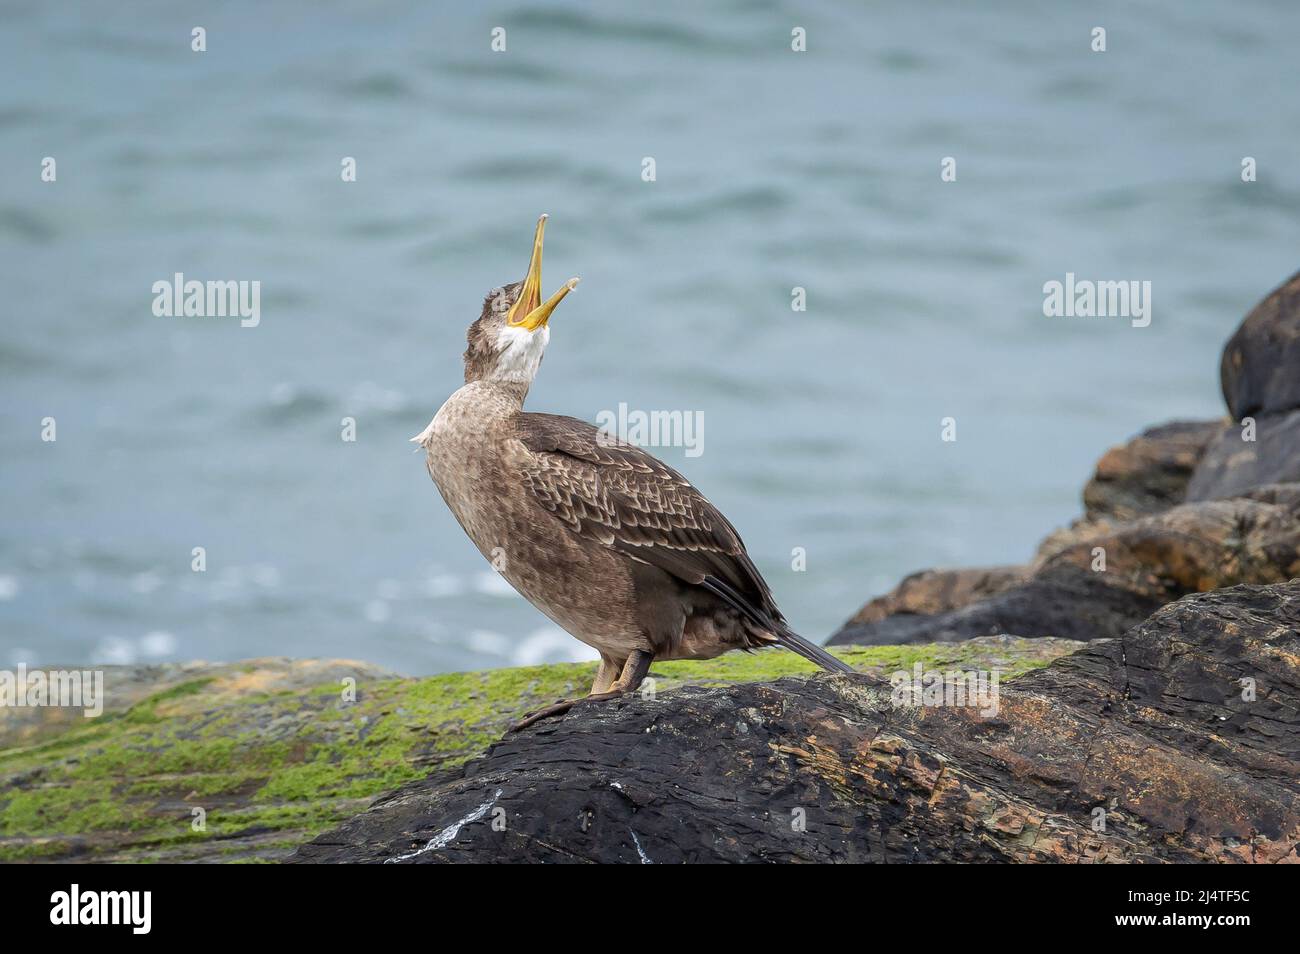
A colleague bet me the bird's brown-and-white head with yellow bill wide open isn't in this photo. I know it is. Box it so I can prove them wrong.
[465,216,577,387]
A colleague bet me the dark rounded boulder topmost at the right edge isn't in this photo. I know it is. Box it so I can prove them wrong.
[1219,272,1300,421]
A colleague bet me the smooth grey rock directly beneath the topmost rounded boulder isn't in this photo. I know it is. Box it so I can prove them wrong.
[1187,413,1300,500]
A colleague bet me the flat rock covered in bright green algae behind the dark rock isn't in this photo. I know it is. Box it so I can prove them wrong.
[0,637,1079,862]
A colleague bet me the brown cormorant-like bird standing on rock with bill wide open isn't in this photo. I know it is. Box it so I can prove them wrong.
[411,214,854,730]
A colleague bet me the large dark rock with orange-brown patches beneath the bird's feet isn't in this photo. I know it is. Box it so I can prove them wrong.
[290,581,1300,864]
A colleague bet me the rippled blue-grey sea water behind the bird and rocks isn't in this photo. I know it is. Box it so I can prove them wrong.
[0,0,1300,673]
